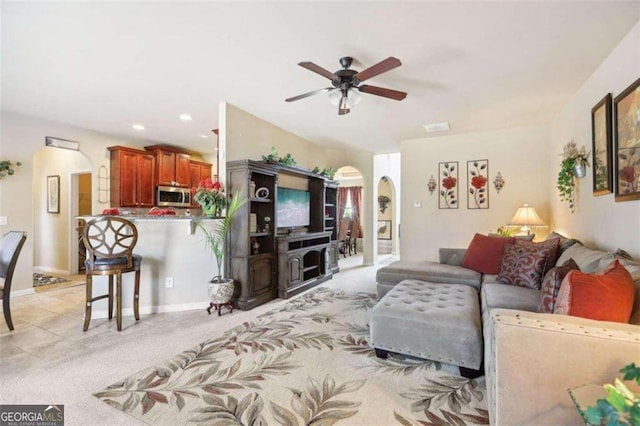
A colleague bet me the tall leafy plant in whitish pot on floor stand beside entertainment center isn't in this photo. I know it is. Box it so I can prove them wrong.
[197,192,247,314]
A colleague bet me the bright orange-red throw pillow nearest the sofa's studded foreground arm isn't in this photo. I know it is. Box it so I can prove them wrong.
[553,259,635,322]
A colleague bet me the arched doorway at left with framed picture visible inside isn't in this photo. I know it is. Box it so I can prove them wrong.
[33,147,94,282]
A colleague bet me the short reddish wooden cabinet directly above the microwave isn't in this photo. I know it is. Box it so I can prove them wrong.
[144,145,191,187]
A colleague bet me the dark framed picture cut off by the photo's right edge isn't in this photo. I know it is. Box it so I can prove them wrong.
[613,78,640,201]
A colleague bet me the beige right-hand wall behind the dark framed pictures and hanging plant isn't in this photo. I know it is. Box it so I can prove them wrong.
[546,23,640,258]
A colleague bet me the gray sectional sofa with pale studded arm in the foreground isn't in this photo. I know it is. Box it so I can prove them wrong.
[376,241,640,425]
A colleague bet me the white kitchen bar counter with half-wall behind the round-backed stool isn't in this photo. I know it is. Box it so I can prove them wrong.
[78,215,220,320]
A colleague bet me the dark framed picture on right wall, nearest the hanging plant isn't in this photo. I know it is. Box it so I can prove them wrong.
[591,93,613,195]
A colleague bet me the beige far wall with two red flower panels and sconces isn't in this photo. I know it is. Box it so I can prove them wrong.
[400,126,550,260]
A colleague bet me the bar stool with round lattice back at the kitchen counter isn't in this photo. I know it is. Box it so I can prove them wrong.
[82,216,142,331]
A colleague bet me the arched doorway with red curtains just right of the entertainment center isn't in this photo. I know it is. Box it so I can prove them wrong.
[334,166,367,269]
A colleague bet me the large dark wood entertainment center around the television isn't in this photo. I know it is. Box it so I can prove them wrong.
[227,160,339,310]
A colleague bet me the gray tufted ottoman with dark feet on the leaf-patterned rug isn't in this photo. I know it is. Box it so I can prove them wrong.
[370,280,482,377]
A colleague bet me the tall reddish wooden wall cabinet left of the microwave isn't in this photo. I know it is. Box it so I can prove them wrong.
[108,146,156,207]
